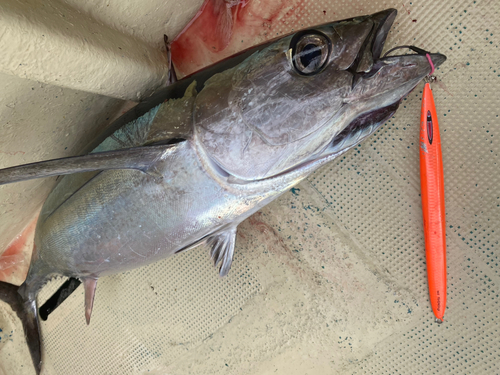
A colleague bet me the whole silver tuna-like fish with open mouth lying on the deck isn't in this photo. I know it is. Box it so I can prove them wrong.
[0,9,445,371]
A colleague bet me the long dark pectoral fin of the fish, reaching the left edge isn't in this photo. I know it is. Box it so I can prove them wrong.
[0,144,176,185]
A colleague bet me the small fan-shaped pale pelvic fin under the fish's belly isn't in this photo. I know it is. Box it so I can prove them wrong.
[207,226,236,277]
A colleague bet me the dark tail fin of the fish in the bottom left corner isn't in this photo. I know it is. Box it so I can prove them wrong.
[0,281,42,375]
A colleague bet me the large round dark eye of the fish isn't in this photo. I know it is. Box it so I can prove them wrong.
[290,31,331,76]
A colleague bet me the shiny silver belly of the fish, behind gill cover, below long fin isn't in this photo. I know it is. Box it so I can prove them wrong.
[32,142,286,284]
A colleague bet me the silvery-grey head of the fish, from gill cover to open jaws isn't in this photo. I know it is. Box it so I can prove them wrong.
[193,9,446,182]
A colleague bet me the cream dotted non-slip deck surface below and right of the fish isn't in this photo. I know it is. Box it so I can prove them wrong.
[0,0,500,375]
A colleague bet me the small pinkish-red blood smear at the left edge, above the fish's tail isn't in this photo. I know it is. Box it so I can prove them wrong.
[0,215,38,284]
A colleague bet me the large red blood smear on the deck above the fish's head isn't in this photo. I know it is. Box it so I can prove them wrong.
[172,0,312,77]
